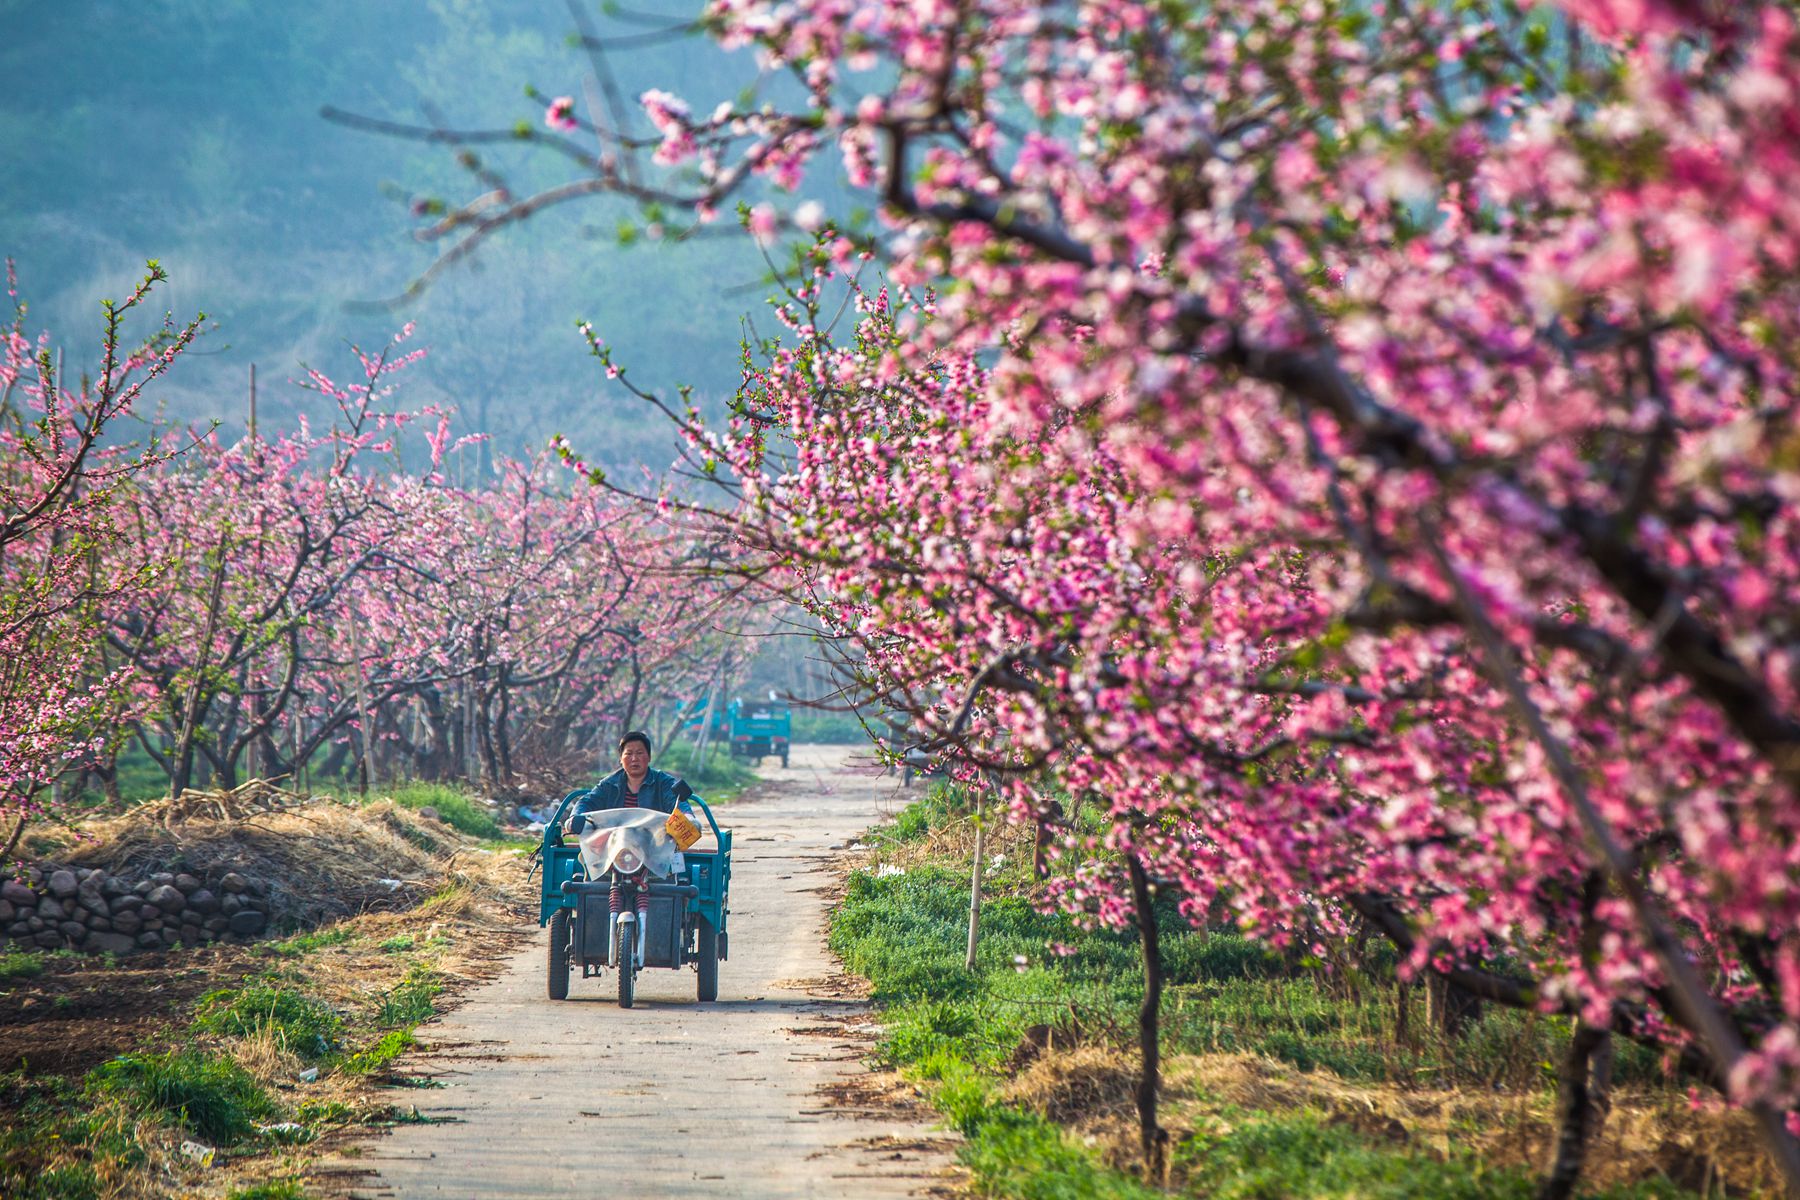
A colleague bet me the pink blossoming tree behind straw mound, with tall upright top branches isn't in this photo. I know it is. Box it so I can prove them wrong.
[106,329,444,793]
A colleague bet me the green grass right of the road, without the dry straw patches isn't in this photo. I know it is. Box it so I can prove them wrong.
[830,788,1685,1200]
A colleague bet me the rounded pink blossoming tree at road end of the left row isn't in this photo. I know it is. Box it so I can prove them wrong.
[356,449,742,786]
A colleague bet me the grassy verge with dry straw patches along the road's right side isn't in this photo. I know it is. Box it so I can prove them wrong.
[832,788,1775,1200]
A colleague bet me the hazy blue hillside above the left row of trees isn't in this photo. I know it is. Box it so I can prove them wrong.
[0,0,795,471]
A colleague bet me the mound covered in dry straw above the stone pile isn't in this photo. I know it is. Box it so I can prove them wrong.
[68,788,473,928]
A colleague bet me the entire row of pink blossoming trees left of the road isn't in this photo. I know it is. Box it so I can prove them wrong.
[0,264,729,849]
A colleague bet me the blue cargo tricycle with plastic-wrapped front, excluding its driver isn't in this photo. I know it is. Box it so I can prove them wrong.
[538,790,731,1007]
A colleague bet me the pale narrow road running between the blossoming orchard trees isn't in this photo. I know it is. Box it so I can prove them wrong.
[315,747,954,1200]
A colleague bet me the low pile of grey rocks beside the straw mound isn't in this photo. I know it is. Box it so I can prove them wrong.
[0,867,270,954]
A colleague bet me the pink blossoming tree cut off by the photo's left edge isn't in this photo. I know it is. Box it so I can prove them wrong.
[0,261,203,855]
